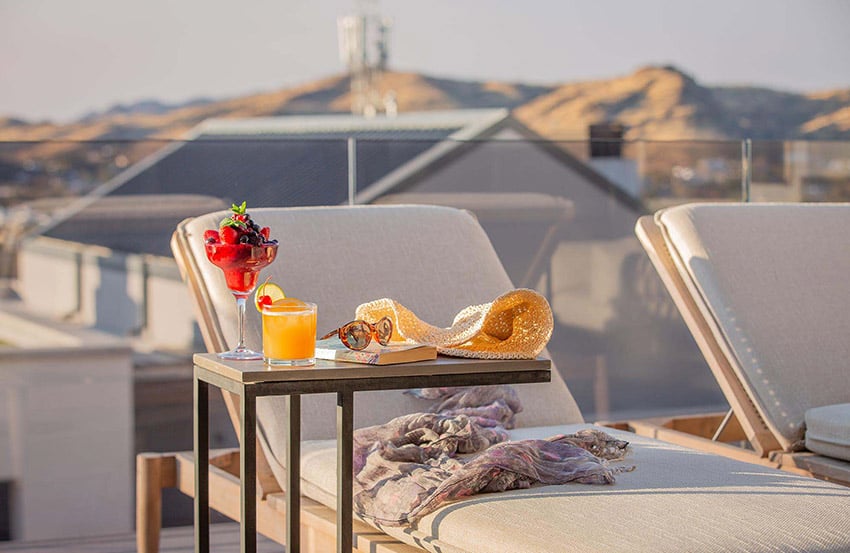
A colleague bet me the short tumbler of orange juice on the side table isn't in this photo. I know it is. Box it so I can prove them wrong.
[263,298,316,366]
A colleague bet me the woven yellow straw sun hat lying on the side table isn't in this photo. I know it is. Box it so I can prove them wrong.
[356,288,553,359]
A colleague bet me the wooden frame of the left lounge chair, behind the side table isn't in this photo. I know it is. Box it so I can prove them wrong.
[136,222,422,553]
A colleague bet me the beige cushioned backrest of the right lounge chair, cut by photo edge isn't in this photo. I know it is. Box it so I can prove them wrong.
[638,204,850,450]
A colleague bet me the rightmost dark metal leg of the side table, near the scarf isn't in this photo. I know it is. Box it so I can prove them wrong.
[336,390,354,553]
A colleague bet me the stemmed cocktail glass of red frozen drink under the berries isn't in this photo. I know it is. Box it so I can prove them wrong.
[206,242,277,361]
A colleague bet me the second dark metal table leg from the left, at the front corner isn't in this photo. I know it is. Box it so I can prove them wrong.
[239,386,257,553]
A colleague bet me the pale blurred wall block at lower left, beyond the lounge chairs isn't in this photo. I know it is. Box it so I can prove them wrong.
[0,304,134,540]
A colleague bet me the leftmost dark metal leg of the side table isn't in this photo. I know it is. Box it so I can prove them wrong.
[193,370,210,553]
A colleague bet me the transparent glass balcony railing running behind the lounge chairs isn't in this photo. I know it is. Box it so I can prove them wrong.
[0,133,850,539]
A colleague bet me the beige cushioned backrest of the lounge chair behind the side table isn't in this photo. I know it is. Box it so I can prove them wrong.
[172,206,582,492]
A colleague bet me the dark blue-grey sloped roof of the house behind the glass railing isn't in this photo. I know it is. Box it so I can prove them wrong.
[103,136,441,207]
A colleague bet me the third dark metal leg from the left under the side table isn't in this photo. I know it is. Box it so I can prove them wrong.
[285,394,301,553]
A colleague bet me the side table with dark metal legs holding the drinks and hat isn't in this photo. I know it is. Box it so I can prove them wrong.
[193,353,551,553]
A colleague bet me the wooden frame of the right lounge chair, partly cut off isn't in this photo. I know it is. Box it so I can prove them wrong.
[606,215,850,486]
